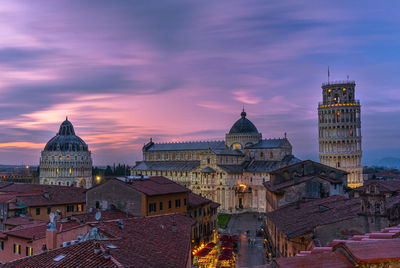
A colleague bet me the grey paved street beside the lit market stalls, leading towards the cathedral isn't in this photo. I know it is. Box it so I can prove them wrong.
[226,213,266,267]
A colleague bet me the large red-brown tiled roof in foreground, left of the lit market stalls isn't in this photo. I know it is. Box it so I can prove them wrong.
[1,214,194,268]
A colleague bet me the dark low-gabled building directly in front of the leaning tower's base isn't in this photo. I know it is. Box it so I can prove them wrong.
[264,160,347,212]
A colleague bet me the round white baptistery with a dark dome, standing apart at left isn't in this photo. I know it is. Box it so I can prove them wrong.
[39,118,92,188]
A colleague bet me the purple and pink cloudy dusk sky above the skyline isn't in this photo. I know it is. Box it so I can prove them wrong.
[0,0,400,164]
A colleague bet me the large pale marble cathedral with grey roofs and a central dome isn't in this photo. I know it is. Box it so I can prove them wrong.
[132,111,300,213]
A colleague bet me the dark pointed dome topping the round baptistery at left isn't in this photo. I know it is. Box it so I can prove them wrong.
[44,118,88,151]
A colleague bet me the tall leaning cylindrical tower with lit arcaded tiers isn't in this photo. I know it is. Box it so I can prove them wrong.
[318,80,363,187]
